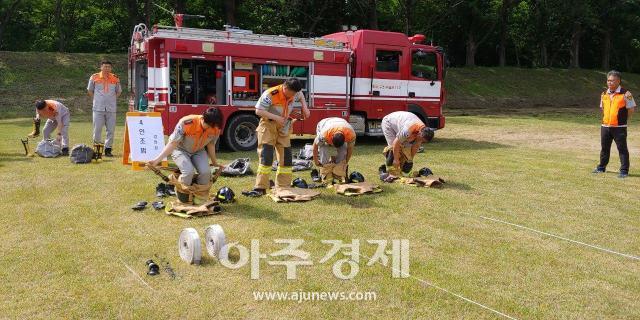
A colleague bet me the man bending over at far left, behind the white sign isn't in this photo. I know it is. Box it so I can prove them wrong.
[29,100,71,156]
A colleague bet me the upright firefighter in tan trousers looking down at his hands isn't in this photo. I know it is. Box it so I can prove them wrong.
[242,78,309,197]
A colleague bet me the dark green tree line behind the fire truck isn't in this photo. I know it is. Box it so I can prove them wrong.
[0,0,640,72]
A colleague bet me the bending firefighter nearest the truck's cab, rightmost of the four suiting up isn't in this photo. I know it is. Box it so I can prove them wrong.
[382,111,433,174]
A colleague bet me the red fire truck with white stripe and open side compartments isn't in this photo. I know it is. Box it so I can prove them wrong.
[129,24,445,151]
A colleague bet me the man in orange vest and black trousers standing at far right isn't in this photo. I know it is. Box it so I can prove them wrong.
[593,70,636,178]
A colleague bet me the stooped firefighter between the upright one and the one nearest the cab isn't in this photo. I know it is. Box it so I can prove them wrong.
[313,118,356,183]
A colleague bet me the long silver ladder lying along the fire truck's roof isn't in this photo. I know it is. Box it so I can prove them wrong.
[150,26,346,51]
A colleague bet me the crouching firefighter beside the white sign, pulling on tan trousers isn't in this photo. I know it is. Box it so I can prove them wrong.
[148,107,222,202]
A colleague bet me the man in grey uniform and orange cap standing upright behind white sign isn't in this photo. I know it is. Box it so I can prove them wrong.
[87,60,122,157]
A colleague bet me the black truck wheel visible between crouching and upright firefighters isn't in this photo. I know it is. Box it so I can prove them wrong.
[224,114,258,151]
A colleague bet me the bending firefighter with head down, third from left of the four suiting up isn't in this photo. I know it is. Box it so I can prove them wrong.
[313,118,356,177]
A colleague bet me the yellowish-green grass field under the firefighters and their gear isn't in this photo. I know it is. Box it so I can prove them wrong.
[0,110,640,319]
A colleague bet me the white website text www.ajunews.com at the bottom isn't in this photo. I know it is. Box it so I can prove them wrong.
[253,291,378,303]
